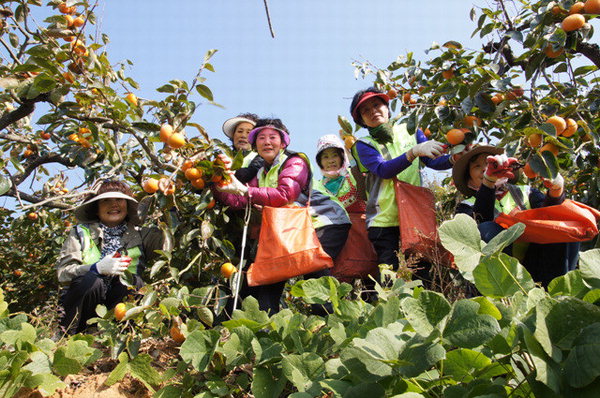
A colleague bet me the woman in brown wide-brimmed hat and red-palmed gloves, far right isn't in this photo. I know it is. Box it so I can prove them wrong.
[452,145,580,286]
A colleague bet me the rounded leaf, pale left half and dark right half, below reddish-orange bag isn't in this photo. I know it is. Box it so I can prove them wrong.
[402,290,452,336]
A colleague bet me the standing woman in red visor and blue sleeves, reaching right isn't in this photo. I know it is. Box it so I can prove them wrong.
[350,87,452,276]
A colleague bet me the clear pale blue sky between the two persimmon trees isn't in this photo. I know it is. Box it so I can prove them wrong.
[96,0,480,163]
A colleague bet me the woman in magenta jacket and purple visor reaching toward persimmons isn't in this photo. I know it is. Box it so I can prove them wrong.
[215,119,350,313]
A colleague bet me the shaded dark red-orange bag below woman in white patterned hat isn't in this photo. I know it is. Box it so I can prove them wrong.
[331,213,378,281]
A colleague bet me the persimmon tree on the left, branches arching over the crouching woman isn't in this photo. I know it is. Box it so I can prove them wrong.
[0,0,234,305]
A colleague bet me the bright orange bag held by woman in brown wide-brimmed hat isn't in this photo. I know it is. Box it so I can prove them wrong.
[495,199,600,243]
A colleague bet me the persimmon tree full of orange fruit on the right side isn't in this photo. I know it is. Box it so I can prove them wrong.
[342,0,600,211]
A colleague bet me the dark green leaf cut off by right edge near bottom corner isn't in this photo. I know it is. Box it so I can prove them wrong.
[565,323,600,387]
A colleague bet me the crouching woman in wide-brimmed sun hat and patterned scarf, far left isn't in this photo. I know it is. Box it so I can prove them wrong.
[56,181,165,333]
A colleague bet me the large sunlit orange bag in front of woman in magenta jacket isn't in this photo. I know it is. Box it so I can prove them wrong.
[247,206,333,286]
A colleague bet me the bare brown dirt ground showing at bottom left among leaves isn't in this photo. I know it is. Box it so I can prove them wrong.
[14,339,178,398]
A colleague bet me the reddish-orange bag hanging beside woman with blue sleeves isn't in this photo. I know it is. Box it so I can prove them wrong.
[394,179,453,266]
